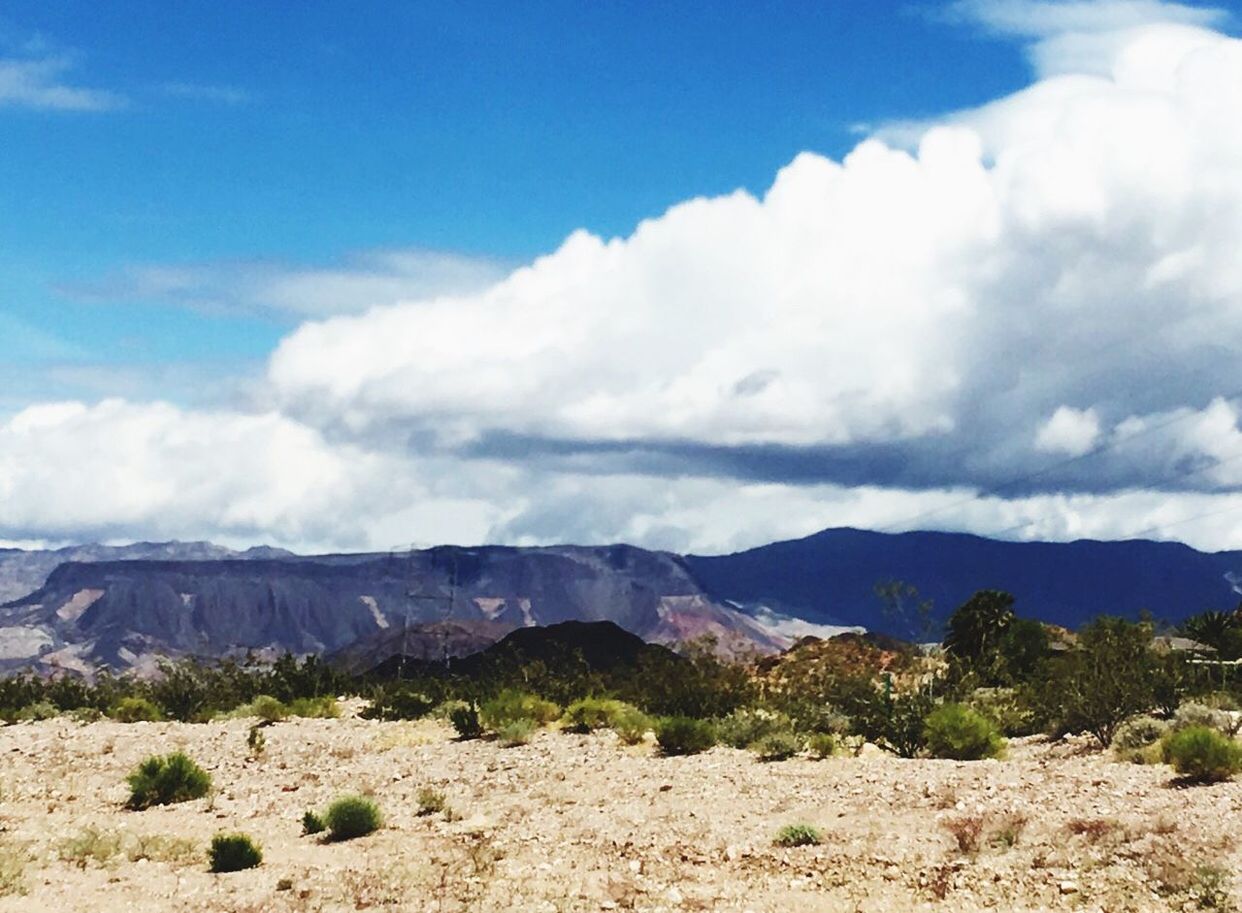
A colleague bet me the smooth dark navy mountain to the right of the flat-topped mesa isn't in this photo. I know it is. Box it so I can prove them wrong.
[684,529,1242,637]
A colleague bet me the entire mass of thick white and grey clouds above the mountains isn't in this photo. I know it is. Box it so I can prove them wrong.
[0,1,1242,552]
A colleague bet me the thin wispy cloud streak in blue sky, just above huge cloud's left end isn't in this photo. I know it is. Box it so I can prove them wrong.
[57,248,507,319]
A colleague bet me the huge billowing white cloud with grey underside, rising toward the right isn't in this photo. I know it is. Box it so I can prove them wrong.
[270,19,1242,492]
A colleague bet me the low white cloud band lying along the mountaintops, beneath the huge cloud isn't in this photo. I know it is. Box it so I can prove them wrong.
[9,400,1242,553]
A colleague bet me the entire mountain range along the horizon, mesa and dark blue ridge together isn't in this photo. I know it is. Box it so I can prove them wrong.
[0,529,1242,673]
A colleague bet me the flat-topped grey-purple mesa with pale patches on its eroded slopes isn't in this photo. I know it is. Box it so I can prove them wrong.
[0,545,786,672]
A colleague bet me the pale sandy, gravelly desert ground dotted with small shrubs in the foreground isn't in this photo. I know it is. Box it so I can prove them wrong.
[0,718,1242,913]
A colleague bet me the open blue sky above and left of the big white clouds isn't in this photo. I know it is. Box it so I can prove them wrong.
[0,0,1027,396]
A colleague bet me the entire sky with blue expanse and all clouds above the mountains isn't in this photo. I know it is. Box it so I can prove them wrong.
[0,0,1242,553]
